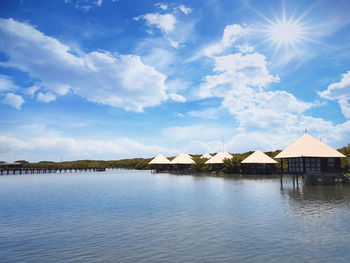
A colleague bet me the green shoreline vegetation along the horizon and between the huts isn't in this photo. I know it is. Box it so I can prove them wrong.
[0,144,350,174]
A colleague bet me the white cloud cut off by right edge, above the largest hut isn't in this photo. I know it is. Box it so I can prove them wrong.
[319,71,350,119]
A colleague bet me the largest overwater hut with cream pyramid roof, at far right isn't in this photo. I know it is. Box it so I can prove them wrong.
[275,134,345,174]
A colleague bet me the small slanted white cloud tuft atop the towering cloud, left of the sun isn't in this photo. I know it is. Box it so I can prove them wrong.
[204,24,249,57]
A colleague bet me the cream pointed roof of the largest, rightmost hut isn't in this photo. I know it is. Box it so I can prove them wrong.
[275,133,345,158]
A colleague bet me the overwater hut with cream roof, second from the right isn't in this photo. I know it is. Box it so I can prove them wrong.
[241,150,277,174]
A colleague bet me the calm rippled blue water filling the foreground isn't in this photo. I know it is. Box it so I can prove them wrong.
[0,171,350,263]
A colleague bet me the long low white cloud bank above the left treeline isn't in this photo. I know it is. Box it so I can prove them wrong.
[0,135,180,161]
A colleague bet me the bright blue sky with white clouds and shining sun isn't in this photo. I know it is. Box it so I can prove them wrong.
[0,0,350,162]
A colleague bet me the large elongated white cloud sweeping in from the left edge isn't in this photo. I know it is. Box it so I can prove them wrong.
[0,19,167,112]
